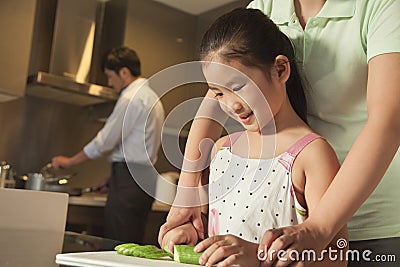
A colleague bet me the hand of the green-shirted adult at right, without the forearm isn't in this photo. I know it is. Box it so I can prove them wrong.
[257,221,331,267]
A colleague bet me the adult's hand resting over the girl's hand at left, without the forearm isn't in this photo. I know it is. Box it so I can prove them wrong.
[158,206,204,248]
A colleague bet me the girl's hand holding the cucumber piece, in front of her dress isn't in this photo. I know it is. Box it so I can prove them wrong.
[195,235,260,267]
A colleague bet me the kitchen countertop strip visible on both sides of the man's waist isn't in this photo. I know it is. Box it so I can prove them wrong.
[68,193,171,212]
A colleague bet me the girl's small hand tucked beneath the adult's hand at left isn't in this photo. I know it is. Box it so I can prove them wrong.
[161,223,198,252]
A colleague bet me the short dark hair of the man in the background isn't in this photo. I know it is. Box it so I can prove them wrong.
[101,47,141,76]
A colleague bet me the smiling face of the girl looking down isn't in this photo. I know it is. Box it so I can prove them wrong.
[203,60,286,132]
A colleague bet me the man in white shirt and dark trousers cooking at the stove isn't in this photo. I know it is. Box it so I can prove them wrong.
[52,47,164,243]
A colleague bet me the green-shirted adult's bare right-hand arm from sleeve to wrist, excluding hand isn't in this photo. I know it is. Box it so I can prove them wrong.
[310,53,400,241]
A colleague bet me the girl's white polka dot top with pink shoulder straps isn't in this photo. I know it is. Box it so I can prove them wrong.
[208,132,320,243]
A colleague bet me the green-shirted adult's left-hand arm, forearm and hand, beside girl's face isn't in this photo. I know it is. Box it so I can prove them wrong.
[158,90,225,244]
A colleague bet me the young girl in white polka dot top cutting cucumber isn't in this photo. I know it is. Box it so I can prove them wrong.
[162,8,347,267]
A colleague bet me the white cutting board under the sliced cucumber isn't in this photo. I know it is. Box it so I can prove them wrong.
[56,251,199,267]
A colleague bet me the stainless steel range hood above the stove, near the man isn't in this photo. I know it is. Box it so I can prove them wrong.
[26,0,126,106]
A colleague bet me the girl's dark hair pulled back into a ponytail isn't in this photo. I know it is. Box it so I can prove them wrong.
[200,8,307,123]
